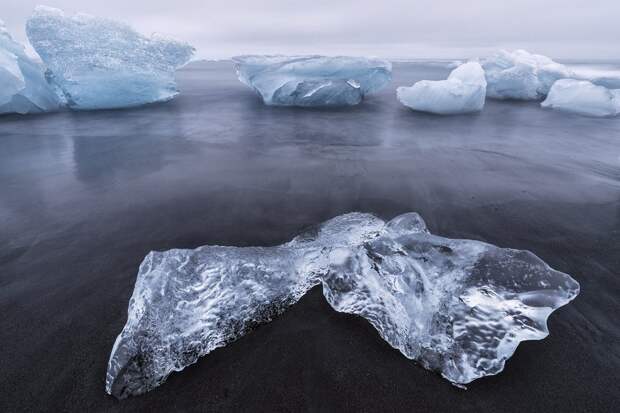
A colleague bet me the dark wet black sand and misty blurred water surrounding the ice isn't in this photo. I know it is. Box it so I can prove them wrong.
[0,63,620,412]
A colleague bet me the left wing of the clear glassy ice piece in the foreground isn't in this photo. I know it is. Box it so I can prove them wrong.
[106,214,383,398]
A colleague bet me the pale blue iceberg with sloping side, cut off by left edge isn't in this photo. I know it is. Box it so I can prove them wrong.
[0,20,58,114]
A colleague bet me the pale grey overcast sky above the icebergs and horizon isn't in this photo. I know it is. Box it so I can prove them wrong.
[0,0,620,59]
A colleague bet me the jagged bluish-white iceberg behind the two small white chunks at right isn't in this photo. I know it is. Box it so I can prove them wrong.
[482,50,574,100]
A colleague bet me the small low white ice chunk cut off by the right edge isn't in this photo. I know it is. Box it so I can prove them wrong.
[541,79,620,117]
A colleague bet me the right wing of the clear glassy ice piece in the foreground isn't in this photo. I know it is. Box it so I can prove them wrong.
[322,213,579,384]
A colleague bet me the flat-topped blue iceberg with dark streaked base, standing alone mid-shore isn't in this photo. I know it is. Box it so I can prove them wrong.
[233,55,392,107]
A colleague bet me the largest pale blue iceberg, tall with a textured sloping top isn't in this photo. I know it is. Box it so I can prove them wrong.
[26,6,194,109]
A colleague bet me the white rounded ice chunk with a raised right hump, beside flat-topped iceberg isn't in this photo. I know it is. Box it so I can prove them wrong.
[396,62,487,115]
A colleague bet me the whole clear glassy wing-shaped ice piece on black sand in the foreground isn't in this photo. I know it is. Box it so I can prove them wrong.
[106,213,579,398]
